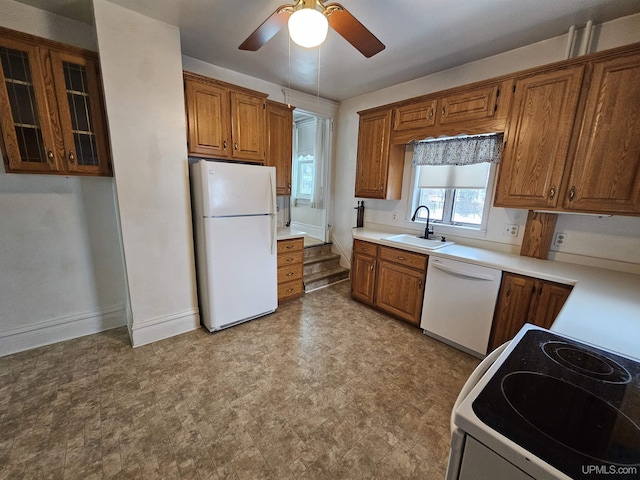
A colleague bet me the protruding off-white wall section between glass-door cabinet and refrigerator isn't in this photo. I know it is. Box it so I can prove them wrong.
[94,0,200,346]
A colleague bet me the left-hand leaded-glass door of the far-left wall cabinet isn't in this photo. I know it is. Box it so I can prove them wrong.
[0,38,64,173]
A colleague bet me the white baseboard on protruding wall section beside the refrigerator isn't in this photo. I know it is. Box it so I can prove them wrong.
[129,308,200,347]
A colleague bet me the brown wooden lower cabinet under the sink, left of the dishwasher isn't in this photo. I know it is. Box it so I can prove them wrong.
[351,240,428,326]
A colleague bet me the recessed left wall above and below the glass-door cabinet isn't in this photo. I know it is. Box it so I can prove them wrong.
[0,0,126,356]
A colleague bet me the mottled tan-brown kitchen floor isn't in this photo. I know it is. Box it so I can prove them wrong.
[0,282,478,480]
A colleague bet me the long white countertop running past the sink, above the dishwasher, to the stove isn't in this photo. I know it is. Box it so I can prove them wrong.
[353,228,640,359]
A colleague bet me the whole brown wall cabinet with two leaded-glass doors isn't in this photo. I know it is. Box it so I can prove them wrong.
[0,28,111,176]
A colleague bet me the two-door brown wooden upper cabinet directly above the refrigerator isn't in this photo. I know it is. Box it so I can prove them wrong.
[184,72,267,163]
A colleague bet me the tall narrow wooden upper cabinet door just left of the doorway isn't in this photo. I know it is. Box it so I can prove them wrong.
[265,101,293,195]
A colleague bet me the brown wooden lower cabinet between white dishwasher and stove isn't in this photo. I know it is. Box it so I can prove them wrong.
[488,272,573,352]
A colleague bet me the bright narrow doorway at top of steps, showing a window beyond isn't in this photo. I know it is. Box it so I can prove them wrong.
[290,109,332,246]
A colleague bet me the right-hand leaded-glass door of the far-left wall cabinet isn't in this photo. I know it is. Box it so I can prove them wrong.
[50,51,110,175]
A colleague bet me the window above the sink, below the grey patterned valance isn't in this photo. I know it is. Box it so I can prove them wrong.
[412,163,495,229]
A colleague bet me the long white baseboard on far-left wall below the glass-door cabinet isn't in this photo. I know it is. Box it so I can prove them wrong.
[0,305,127,357]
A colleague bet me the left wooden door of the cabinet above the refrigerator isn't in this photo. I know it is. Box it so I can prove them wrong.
[185,79,231,158]
